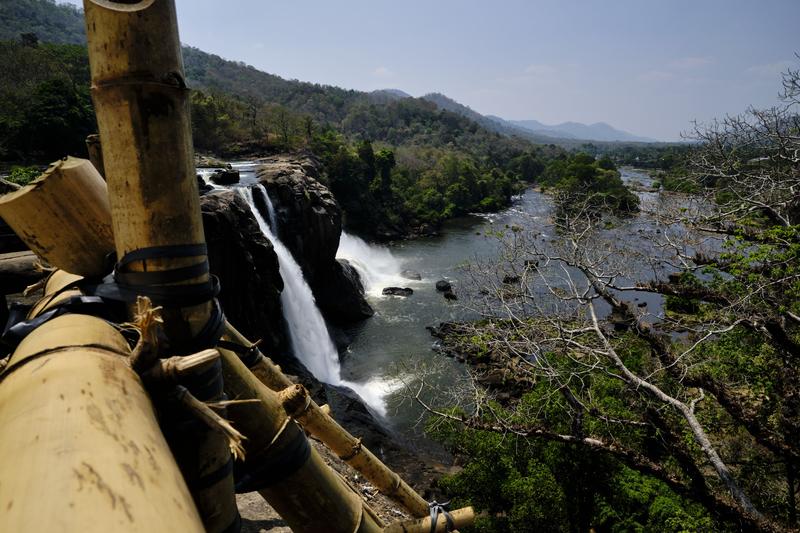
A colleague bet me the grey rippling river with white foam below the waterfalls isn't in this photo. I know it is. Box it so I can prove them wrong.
[206,162,700,441]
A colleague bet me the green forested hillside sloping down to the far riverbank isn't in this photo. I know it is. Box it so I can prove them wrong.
[0,0,560,237]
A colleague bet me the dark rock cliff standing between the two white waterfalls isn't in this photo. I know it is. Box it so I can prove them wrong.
[257,155,373,325]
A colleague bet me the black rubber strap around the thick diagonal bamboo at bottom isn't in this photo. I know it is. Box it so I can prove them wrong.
[234,429,311,494]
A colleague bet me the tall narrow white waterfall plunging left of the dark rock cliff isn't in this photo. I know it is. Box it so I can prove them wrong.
[236,184,388,415]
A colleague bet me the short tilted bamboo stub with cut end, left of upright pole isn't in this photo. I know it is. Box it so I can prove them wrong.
[0,157,114,276]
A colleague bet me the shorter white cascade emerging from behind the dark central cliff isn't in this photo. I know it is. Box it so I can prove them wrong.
[336,231,409,296]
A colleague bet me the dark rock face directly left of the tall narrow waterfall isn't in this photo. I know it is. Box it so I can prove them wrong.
[200,190,288,354]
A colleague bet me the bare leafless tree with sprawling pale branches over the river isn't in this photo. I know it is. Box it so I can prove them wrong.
[409,64,800,530]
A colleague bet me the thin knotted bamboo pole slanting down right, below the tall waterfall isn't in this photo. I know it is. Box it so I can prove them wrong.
[225,324,446,517]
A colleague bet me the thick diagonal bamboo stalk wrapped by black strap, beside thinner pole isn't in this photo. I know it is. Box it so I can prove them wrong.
[219,349,383,533]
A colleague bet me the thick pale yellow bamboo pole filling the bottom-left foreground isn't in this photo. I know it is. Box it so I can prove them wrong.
[0,315,203,533]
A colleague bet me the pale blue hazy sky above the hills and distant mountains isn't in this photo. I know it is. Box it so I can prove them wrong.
[62,0,800,140]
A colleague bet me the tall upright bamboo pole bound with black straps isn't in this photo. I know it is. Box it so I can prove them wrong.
[83,0,239,532]
